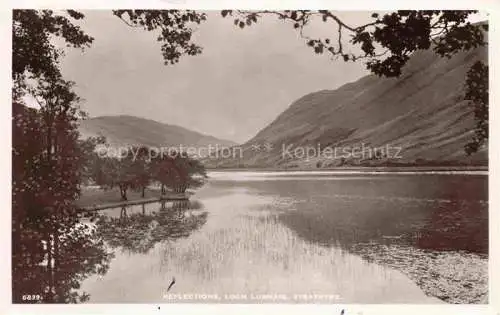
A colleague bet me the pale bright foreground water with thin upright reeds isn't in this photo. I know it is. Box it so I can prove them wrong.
[154,194,436,303]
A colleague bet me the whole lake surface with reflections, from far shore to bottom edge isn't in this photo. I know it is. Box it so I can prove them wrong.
[79,172,488,303]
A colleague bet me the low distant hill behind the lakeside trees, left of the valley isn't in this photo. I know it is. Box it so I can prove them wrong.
[79,115,236,156]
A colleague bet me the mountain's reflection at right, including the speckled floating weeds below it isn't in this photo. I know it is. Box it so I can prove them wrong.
[204,175,488,303]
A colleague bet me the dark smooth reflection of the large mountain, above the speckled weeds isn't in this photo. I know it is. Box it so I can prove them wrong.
[215,176,488,254]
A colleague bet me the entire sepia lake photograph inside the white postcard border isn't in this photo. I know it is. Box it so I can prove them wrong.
[6,7,491,313]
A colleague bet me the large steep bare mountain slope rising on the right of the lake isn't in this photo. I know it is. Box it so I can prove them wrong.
[205,41,488,168]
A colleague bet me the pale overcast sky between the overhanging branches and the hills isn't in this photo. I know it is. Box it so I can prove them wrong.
[56,11,486,143]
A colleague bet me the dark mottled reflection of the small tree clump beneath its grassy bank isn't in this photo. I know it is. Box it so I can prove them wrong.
[96,201,208,254]
